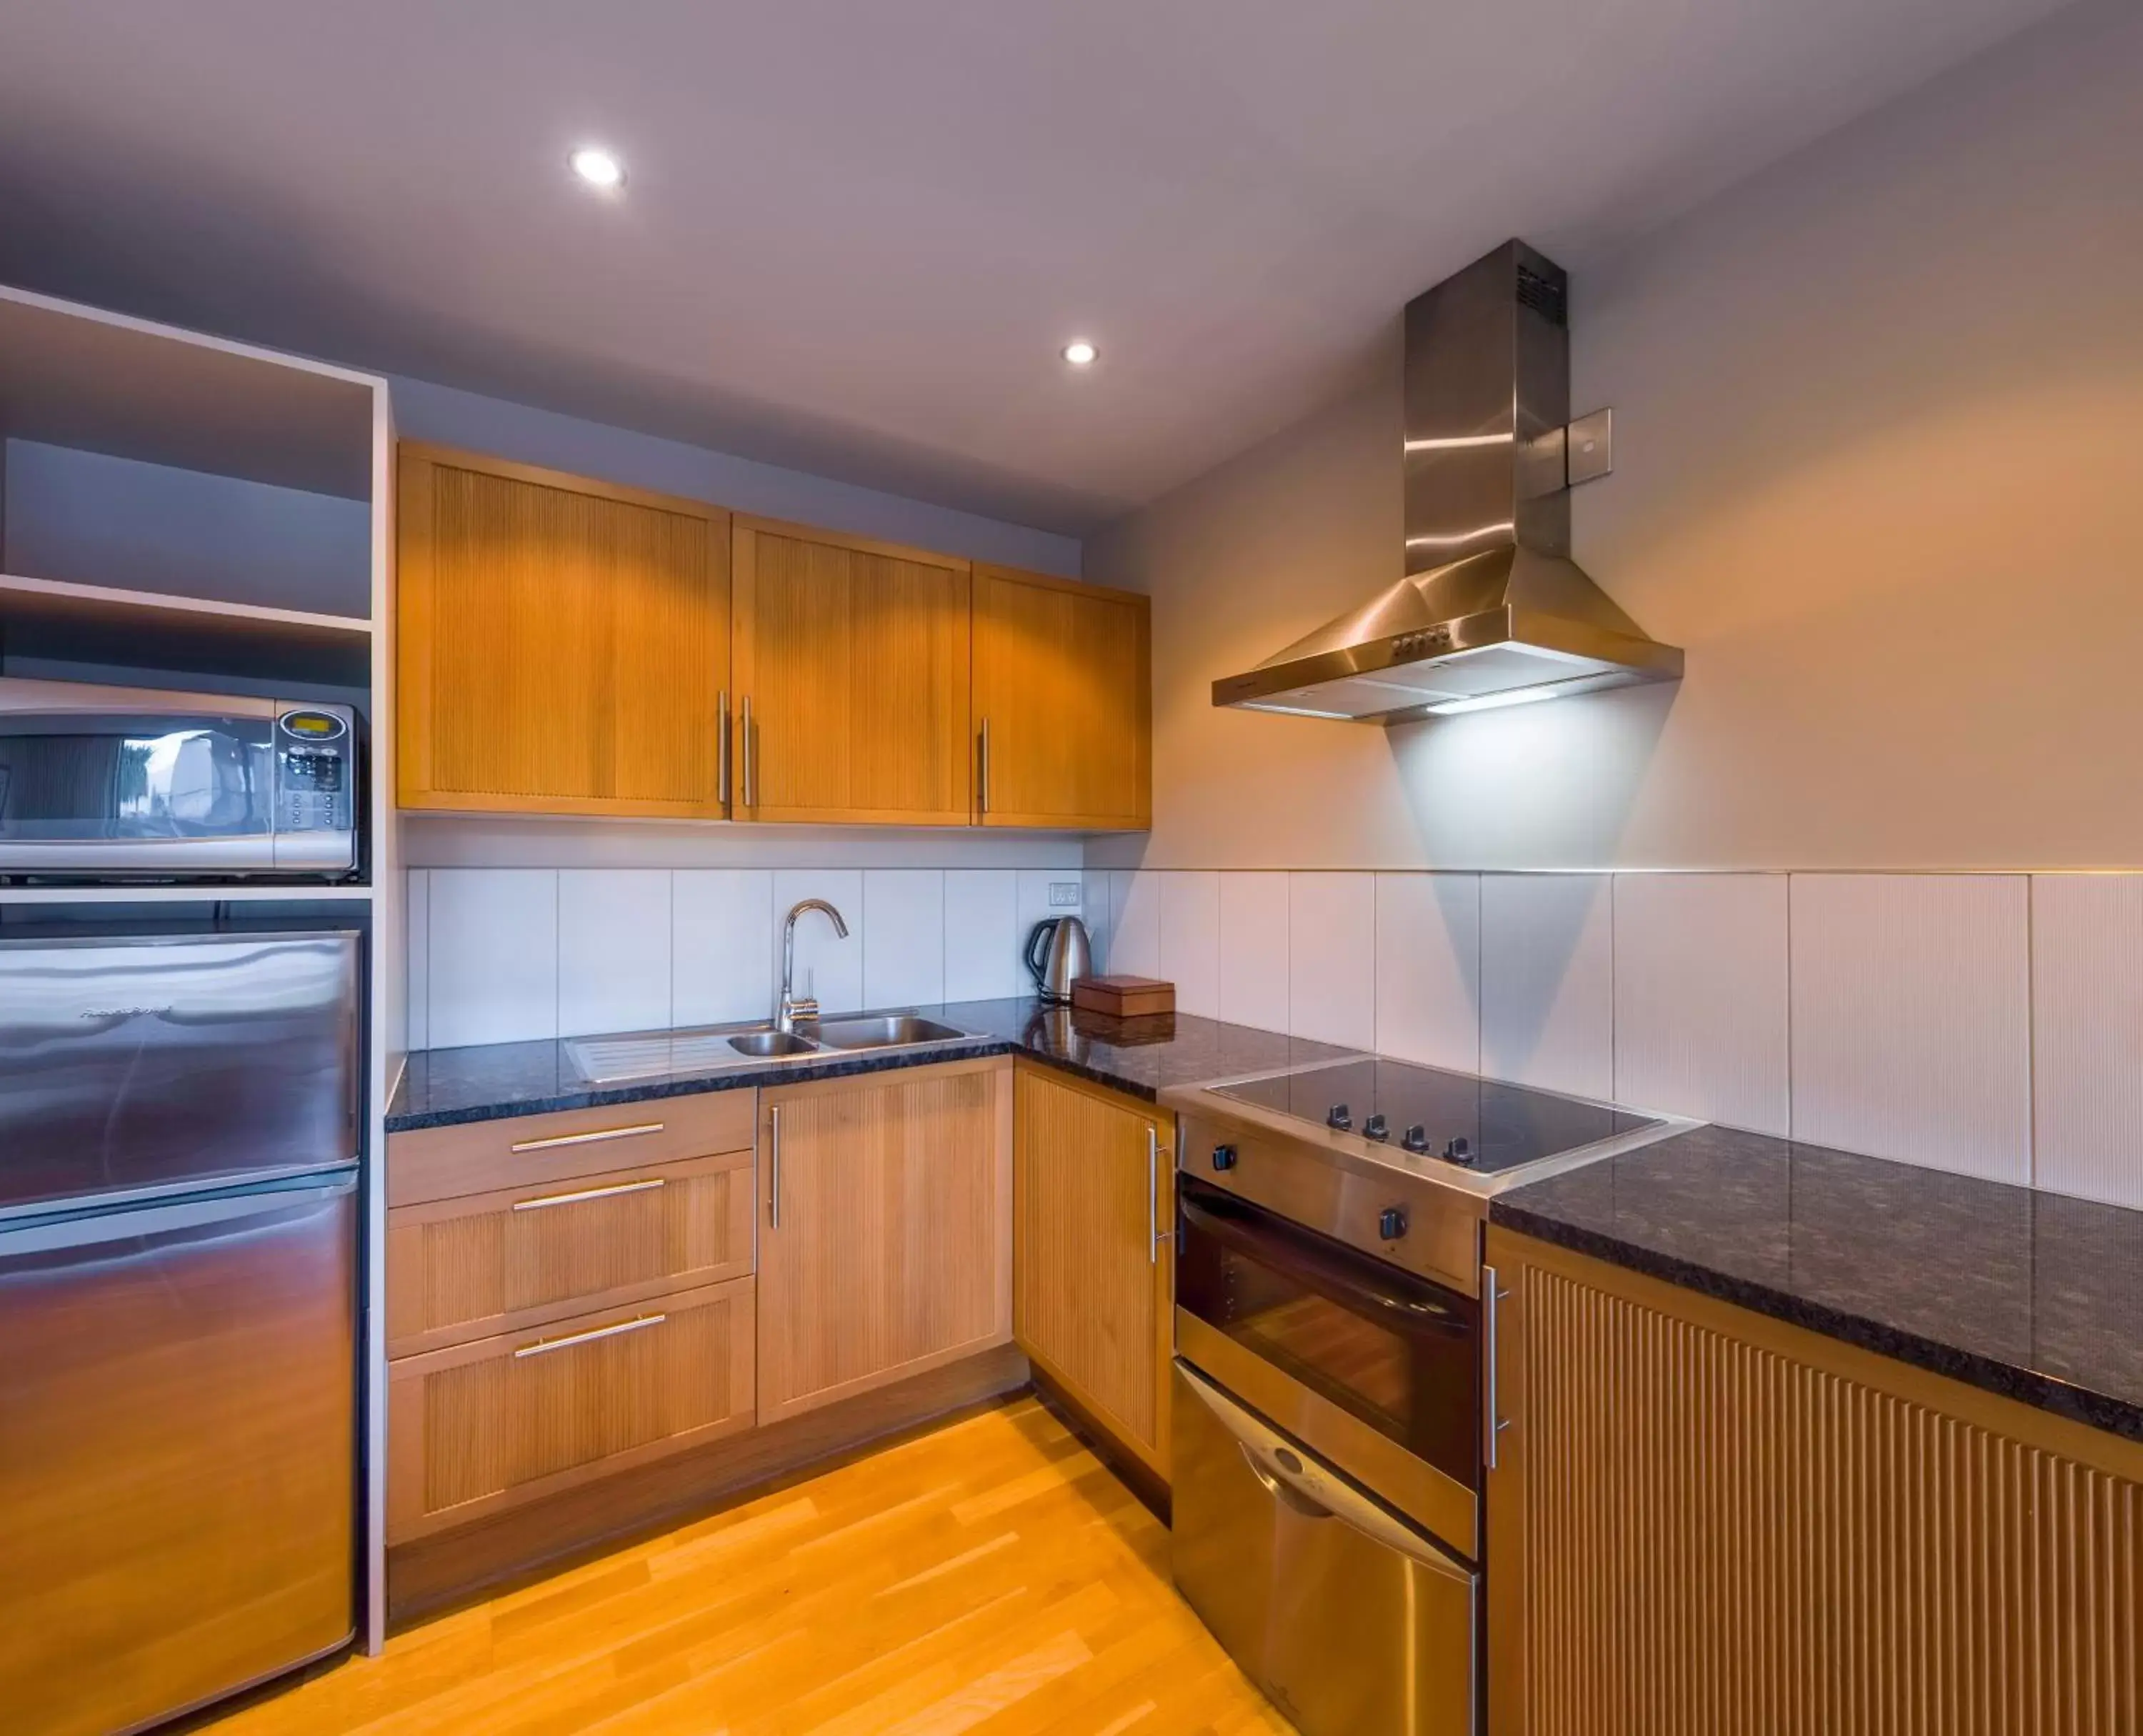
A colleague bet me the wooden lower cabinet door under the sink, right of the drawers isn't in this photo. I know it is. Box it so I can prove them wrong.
[759,1057,1011,1423]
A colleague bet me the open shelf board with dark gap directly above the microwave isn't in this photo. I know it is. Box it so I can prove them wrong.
[0,574,373,688]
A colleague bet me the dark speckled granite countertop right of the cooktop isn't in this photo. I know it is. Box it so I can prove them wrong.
[1489,1127,2143,1440]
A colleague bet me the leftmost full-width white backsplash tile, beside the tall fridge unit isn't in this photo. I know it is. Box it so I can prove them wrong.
[426,868,557,1048]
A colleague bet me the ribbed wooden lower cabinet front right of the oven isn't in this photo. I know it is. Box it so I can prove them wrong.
[1487,1226,2143,1736]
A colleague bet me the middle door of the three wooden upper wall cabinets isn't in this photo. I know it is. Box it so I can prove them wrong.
[733,519,973,825]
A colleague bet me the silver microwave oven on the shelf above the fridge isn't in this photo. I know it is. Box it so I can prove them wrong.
[0,677,360,881]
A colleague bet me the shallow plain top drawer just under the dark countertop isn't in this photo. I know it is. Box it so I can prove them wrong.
[388,1089,759,1207]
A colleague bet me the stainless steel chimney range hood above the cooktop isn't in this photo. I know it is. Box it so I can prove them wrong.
[1213,240,1682,724]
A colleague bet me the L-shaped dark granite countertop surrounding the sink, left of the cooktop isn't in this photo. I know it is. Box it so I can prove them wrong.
[388,997,1352,1134]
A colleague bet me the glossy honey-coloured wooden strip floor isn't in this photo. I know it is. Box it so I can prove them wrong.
[208,1397,1290,1736]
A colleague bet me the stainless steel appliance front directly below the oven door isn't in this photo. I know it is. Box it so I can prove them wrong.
[1172,1361,1479,1736]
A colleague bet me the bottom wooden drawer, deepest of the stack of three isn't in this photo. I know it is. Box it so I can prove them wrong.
[388,1277,754,1543]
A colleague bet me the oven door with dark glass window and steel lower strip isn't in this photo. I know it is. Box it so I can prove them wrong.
[1177,1177,1481,1558]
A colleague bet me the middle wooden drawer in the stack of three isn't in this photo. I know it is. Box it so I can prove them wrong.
[388,1144,756,1357]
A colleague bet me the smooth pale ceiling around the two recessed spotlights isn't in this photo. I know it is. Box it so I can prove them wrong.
[0,0,2062,532]
